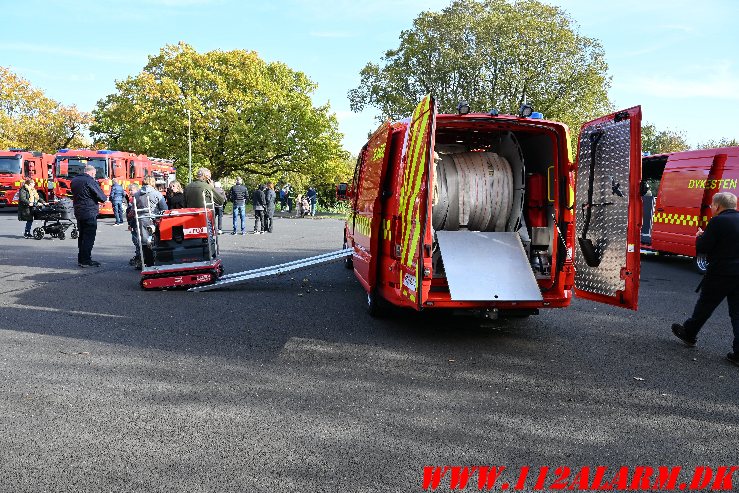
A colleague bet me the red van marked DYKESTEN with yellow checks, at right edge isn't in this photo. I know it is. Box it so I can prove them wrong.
[641,147,739,272]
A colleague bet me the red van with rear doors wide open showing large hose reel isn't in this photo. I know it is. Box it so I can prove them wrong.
[339,96,642,317]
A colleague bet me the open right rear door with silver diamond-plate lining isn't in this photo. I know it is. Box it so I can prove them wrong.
[574,106,642,310]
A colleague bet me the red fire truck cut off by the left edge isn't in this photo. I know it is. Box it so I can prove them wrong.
[0,149,54,208]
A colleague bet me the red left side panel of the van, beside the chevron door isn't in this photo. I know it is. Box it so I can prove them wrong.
[352,123,391,290]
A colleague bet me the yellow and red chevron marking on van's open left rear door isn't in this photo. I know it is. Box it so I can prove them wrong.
[398,95,434,302]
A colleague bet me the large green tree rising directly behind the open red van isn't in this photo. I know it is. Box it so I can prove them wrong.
[349,0,611,140]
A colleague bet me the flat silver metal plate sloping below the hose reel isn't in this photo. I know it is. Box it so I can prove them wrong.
[436,231,543,301]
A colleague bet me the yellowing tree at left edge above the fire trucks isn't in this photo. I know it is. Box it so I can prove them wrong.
[0,67,91,153]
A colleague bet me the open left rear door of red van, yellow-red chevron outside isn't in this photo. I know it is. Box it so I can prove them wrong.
[393,95,436,306]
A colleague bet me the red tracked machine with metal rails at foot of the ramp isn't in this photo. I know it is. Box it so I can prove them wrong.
[136,196,223,290]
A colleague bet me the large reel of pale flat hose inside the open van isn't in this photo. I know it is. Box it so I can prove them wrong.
[431,152,514,231]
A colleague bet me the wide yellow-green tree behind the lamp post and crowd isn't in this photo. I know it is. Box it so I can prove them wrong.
[91,43,345,182]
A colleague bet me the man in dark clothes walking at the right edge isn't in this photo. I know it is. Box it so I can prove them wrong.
[672,192,739,366]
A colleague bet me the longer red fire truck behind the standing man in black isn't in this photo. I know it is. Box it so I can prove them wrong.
[54,149,175,215]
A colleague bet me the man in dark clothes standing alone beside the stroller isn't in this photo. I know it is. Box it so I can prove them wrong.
[70,164,108,267]
